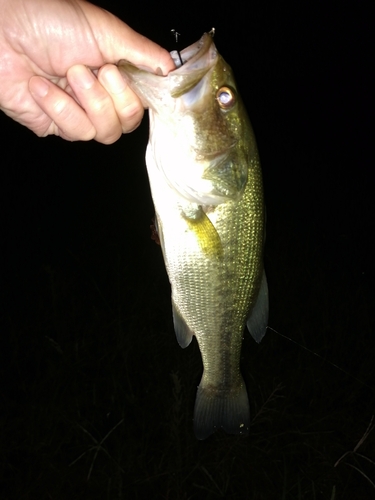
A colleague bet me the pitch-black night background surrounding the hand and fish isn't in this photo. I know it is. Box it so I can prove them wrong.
[0,0,375,500]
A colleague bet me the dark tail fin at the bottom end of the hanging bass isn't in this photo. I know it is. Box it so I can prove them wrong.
[194,379,250,439]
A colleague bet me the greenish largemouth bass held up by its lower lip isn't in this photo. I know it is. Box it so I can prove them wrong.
[118,32,268,440]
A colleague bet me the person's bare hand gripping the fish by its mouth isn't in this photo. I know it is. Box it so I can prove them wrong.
[0,0,175,144]
